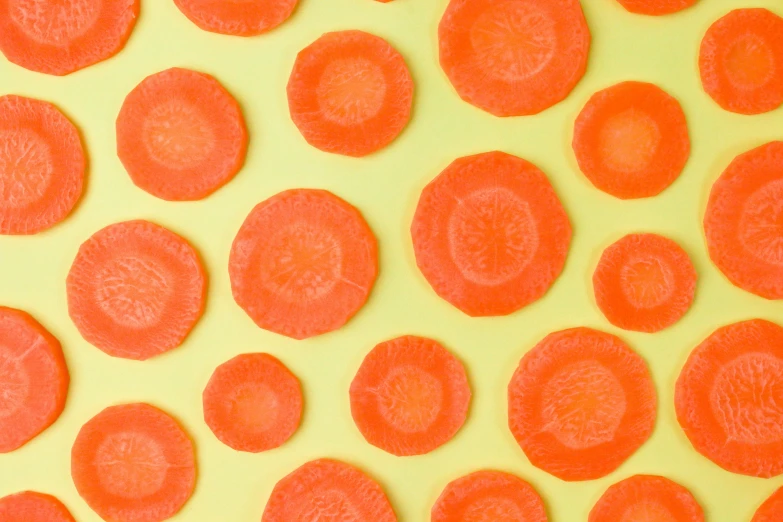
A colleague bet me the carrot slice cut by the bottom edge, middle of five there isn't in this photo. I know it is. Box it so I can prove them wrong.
[430,470,548,522]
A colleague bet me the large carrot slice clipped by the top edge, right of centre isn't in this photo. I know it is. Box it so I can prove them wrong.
[438,0,590,116]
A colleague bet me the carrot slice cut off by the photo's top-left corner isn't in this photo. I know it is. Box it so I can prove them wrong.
[0,0,139,76]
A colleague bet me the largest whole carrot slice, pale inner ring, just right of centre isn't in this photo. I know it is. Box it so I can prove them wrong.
[411,152,571,316]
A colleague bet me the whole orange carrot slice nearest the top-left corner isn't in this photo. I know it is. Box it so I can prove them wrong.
[117,68,248,201]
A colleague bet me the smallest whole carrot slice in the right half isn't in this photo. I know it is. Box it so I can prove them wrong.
[593,234,697,333]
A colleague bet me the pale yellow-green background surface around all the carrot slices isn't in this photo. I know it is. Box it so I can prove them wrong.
[0,0,783,522]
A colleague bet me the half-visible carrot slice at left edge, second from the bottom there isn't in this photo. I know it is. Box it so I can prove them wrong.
[0,306,69,450]
